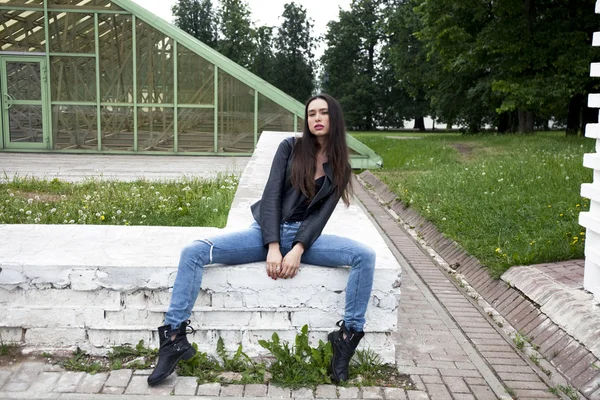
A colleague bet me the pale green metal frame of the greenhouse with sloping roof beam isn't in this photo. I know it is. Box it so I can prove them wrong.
[0,0,382,168]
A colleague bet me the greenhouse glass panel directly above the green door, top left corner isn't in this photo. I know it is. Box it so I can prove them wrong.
[0,10,46,52]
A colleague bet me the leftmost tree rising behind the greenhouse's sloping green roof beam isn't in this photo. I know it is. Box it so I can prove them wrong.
[172,0,217,49]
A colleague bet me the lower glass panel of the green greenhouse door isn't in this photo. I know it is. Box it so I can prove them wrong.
[8,104,44,143]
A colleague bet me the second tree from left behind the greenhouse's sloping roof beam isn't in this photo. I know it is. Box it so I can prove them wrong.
[217,0,254,68]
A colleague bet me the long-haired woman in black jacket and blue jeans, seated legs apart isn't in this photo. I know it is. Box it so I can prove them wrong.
[148,94,375,385]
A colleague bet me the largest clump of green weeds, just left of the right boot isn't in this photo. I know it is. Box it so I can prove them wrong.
[258,325,332,388]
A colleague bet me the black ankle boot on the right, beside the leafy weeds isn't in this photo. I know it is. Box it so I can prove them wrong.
[327,321,365,383]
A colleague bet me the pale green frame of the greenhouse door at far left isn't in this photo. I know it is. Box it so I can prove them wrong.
[0,55,51,150]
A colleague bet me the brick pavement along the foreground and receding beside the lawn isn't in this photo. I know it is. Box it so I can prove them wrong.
[0,173,584,400]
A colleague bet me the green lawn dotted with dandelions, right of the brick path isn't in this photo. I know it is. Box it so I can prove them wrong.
[352,132,595,276]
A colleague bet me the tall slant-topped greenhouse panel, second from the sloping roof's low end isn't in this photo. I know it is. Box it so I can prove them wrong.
[218,70,254,153]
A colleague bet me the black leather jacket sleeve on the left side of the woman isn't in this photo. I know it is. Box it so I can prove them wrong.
[257,138,294,246]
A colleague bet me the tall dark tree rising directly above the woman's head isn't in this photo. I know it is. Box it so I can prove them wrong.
[273,2,316,102]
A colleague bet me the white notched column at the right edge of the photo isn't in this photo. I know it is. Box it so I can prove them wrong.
[579,1,600,302]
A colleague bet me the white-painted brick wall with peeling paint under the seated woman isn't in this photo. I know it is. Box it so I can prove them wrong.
[0,133,400,363]
